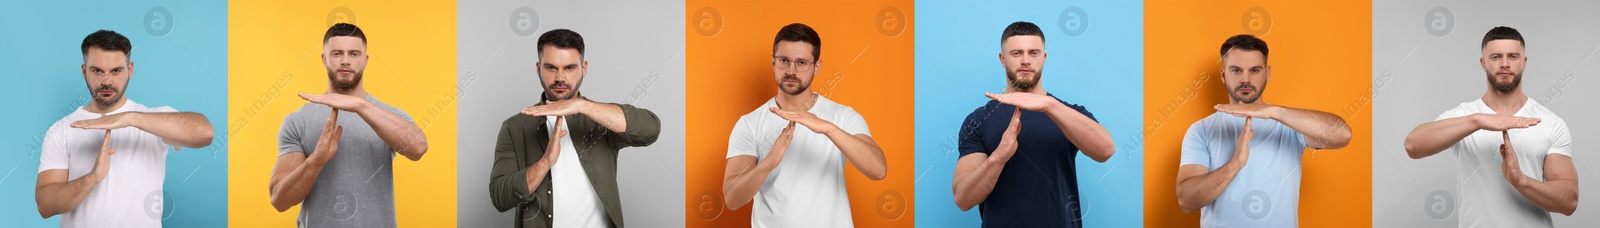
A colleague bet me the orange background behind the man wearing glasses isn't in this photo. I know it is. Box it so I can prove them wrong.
[685,0,915,228]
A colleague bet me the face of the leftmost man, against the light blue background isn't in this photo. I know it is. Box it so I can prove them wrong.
[82,47,133,106]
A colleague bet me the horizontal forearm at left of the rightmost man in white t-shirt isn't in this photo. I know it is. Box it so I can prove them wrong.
[1405,116,1480,159]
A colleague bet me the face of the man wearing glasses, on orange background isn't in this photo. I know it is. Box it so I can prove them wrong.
[773,42,822,95]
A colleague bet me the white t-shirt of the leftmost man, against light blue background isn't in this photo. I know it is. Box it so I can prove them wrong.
[38,100,178,228]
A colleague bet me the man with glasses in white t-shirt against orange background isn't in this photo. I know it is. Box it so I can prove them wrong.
[722,22,888,228]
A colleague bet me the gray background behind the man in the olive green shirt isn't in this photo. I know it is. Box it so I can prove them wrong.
[456,0,685,226]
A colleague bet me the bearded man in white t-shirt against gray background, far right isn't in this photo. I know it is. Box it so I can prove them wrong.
[1405,27,1578,226]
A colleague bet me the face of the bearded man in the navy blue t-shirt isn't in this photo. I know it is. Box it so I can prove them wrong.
[1000,35,1045,90]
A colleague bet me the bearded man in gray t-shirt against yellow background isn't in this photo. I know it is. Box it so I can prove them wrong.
[269,22,427,228]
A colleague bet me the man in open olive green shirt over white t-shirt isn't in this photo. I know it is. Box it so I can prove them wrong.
[490,29,661,228]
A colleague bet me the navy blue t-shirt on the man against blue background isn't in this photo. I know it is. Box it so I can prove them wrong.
[960,95,1098,228]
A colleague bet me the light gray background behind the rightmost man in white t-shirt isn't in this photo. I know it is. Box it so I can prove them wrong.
[1371,0,1600,228]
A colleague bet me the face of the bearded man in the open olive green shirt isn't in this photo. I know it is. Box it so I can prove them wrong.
[538,45,589,101]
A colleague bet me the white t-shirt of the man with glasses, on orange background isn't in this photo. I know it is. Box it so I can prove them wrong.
[728,96,872,228]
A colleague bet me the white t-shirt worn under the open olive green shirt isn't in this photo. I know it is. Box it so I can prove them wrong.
[544,117,611,228]
